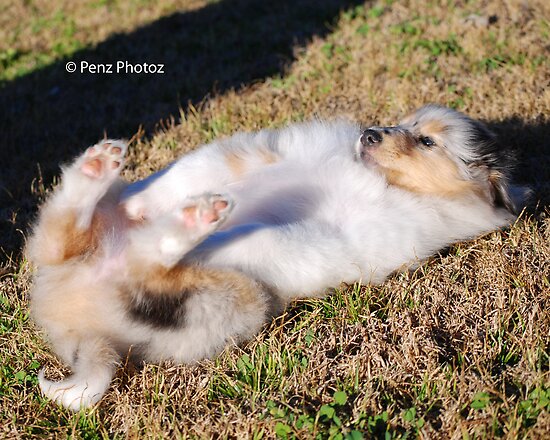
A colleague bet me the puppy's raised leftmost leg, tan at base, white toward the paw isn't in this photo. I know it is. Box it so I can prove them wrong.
[28,140,126,266]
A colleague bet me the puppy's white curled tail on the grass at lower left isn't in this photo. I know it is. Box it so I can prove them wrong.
[38,338,119,411]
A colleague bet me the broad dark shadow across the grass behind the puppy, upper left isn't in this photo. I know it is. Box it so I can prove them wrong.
[0,0,370,258]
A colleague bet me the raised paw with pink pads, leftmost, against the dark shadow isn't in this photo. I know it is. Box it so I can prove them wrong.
[77,139,127,180]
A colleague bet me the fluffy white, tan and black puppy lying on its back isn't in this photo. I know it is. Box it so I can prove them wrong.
[28,106,519,410]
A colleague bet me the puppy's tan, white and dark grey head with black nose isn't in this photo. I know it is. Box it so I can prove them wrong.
[357,105,516,212]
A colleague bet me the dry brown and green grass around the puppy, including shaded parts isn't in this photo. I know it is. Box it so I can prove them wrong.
[0,0,550,439]
